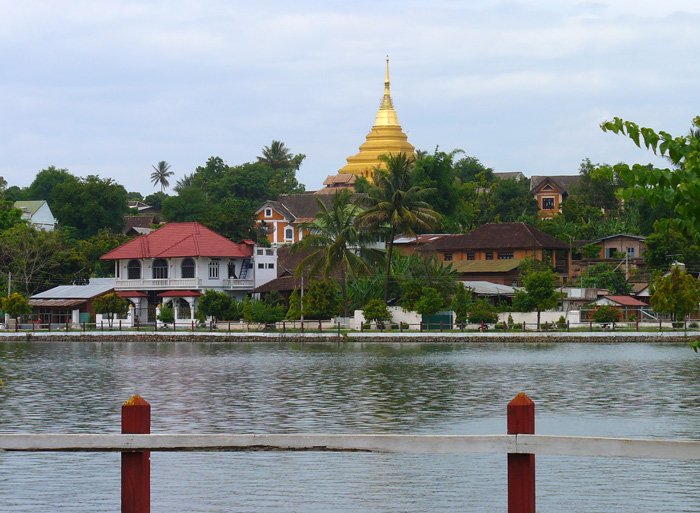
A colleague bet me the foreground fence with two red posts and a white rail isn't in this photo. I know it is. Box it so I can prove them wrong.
[0,394,700,513]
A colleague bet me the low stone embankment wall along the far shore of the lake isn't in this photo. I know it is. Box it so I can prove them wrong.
[0,331,700,344]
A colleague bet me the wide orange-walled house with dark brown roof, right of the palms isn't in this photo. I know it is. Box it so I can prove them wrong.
[419,223,571,285]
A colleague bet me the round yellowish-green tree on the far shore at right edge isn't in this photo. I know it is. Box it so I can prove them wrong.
[650,265,700,321]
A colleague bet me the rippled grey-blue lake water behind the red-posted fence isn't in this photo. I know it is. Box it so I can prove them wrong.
[0,342,700,513]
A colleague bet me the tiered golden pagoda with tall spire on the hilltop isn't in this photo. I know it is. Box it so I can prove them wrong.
[338,55,416,181]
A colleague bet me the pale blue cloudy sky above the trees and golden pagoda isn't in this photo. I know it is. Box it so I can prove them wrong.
[0,0,700,194]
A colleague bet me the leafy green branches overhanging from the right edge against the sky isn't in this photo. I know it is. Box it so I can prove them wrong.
[596,116,700,241]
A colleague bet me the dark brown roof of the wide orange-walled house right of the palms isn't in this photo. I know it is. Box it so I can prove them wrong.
[420,223,569,252]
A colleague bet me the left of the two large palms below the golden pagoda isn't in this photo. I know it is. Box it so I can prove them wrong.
[291,189,377,317]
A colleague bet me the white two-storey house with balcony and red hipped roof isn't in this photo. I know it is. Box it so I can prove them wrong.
[101,223,268,322]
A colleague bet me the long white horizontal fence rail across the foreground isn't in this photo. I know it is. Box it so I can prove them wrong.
[0,434,700,460]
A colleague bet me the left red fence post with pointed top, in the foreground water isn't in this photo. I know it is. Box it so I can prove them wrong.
[122,395,151,513]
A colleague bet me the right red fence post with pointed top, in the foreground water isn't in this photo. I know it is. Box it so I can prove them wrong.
[508,393,535,513]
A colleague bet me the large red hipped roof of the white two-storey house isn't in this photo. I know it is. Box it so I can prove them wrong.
[100,223,253,260]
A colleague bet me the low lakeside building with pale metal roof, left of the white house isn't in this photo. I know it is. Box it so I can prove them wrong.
[29,278,117,325]
